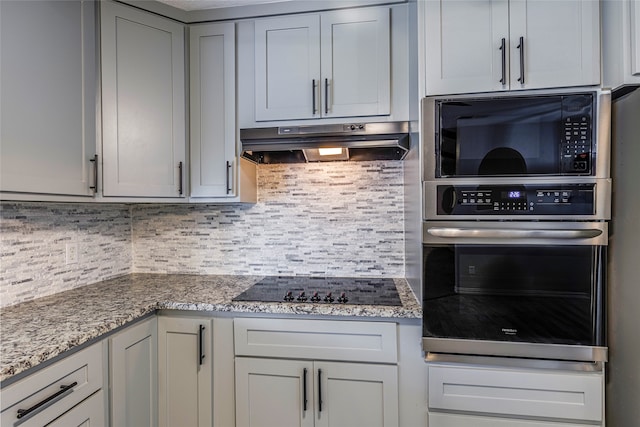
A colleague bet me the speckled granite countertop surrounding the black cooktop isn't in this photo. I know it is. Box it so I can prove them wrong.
[0,274,422,381]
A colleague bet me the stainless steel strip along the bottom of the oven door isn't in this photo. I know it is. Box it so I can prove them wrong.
[422,340,608,362]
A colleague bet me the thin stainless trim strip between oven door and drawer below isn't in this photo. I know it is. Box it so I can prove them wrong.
[424,352,604,372]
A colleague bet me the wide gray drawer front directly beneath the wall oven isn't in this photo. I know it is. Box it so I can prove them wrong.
[428,365,604,421]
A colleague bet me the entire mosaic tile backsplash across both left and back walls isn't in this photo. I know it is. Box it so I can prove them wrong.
[0,161,404,307]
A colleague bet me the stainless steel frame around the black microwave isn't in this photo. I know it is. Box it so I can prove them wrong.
[420,87,611,184]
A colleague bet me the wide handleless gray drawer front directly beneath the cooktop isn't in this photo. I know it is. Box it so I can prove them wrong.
[234,318,398,363]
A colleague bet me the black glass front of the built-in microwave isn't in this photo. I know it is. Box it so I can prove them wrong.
[436,96,591,177]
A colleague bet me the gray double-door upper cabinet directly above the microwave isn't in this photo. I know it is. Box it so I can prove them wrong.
[424,0,600,95]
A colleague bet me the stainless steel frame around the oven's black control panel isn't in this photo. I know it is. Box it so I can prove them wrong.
[422,177,611,221]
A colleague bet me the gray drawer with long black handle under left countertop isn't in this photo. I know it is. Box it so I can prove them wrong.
[0,342,103,427]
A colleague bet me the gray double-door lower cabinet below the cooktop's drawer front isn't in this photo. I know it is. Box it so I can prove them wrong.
[236,357,398,427]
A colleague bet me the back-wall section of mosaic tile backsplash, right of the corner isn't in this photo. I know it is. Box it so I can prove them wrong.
[132,161,404,277]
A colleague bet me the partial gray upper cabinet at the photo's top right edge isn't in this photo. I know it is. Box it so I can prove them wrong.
[602,0,640,89]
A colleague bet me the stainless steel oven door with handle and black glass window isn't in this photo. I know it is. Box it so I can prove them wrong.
[423,222,608,361]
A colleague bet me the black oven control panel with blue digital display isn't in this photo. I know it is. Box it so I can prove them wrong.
[437,184,595,216]
